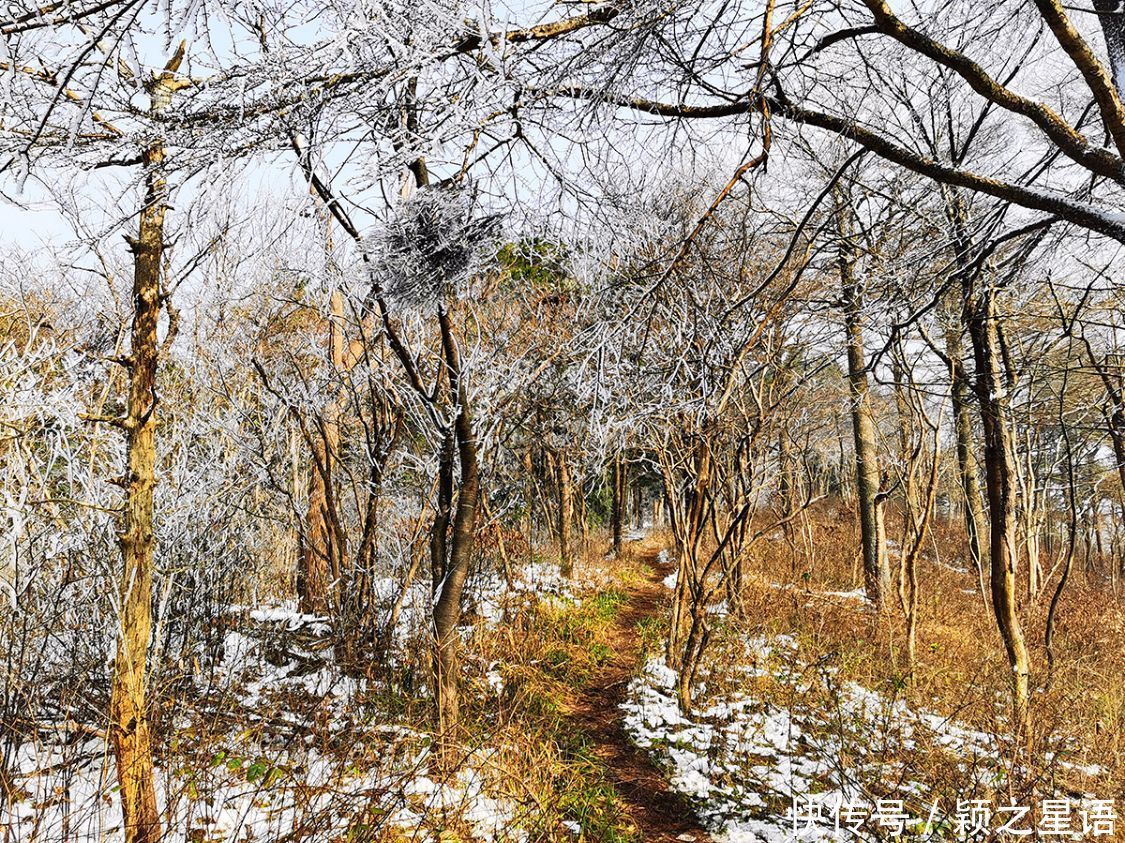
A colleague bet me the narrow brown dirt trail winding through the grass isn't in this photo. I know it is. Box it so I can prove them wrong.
[570,549,711,843]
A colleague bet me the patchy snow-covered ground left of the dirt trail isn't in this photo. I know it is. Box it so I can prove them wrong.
[0,565,553,843]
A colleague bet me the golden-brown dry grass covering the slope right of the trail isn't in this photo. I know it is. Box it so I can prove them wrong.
[684,505,1125,834]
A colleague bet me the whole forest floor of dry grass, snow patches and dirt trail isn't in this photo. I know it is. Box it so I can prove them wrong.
[0,511,1125,843]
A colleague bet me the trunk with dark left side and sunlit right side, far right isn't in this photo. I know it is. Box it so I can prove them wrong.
[966,289,1031,741]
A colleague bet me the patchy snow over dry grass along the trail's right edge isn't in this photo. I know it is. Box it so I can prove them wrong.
[622,635,1089,843]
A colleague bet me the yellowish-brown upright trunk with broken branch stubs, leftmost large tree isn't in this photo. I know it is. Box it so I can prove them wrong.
[109,62,182,843]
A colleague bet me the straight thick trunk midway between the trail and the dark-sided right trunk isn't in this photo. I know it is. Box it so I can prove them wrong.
[839,223,891,612]
